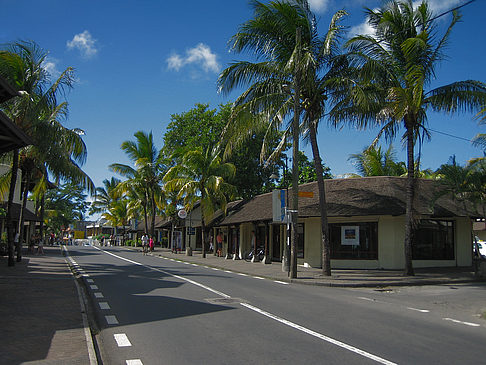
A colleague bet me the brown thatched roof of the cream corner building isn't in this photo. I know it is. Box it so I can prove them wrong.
[221,176,468,225]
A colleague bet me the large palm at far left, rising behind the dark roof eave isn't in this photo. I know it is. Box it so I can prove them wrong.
[0,42,92,266]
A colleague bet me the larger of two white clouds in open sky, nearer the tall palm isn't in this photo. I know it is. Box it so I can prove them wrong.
[167,43,221,73]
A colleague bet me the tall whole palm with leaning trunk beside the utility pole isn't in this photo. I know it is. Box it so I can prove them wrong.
[219,0,346,276]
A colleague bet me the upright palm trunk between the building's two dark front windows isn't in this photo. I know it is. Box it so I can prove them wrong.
[403,121,415,276]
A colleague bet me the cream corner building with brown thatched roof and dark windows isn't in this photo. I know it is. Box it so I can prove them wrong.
[215,177,472,269]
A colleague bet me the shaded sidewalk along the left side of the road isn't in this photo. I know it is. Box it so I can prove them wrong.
[0,247,94,365]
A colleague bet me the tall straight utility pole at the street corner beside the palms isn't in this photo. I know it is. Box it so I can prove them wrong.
[290,27,301,278]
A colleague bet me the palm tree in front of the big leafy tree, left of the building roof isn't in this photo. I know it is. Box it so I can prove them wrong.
[164,147,235,257]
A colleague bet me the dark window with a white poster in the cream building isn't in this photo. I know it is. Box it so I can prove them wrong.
[329,222,378,260]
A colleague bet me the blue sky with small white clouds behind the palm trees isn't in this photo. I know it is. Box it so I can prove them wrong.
[0,0,486,192]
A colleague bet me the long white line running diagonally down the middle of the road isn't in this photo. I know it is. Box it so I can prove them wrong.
[93,246,397,365]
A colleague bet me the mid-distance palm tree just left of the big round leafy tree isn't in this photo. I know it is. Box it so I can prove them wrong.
[110,131,166,236]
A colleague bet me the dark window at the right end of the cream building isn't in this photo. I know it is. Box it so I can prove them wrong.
[412,219,454,260]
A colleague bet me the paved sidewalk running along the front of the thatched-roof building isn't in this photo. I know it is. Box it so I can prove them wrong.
[139,247,484,288]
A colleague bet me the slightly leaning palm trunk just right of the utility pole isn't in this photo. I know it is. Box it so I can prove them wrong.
[309,122,331,276]
